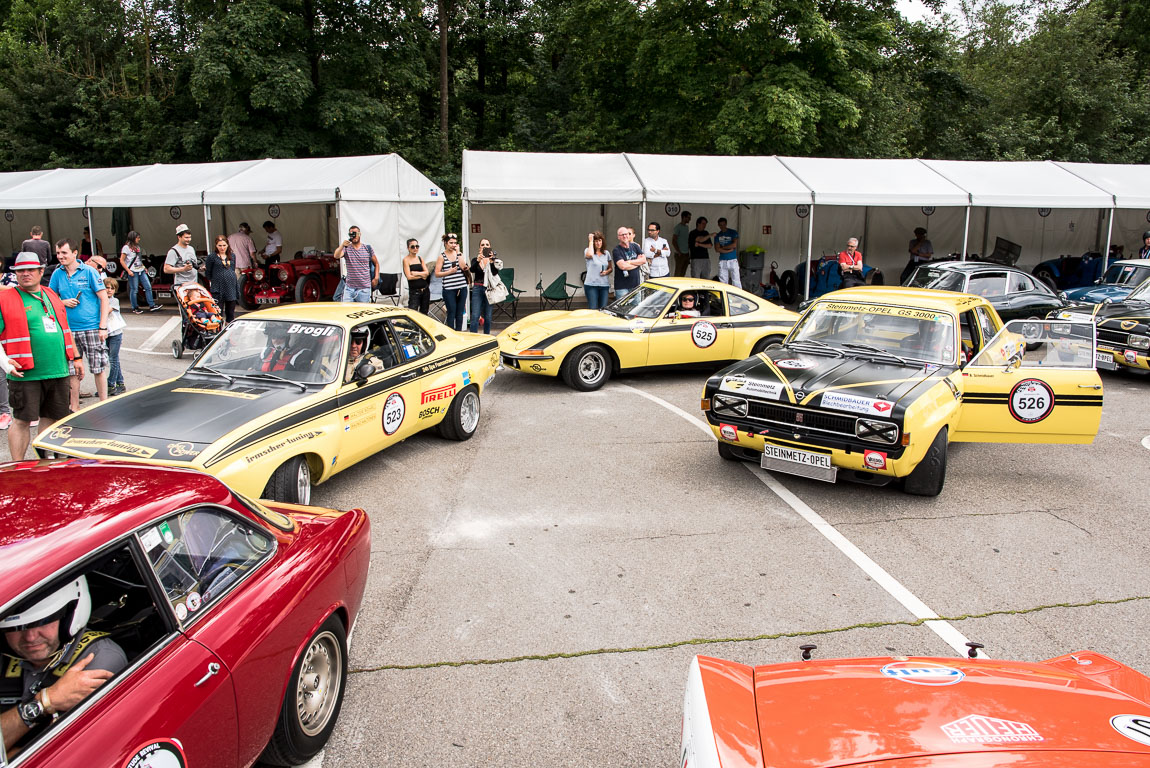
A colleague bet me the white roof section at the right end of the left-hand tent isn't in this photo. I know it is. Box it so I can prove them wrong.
[204,154,444,206]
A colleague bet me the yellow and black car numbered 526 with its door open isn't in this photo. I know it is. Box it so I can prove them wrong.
[702,287,1102,496]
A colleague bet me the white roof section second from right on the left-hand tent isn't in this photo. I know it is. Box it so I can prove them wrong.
[87,160,262,208]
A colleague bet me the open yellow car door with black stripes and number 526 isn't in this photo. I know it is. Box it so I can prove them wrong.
[950,320,1102,443]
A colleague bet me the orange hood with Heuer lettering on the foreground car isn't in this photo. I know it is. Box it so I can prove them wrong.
[754,659,1150,768]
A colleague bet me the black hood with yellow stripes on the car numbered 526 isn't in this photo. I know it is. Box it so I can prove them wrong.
[713,346,956,418]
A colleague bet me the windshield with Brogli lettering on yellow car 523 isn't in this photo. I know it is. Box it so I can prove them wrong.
[190,320,344,384]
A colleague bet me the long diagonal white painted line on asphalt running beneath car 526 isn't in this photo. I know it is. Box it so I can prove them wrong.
[615,383,989,659]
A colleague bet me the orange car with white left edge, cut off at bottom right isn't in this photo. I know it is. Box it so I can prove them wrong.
[679,651,1150,768]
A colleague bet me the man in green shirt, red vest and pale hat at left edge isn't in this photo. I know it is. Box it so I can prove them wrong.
[0,252,84,461]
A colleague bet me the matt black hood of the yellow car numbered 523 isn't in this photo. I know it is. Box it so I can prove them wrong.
[37,374,307,462]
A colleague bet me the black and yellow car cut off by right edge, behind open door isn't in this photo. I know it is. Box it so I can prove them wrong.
[1049,281,1150,370]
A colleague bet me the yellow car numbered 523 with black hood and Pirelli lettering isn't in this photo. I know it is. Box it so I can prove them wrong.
[35,304,499,504]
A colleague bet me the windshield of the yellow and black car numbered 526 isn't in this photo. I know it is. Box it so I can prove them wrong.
[787,301,957,364]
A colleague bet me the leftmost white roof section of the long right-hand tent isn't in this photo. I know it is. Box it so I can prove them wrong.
[463,149,643,202]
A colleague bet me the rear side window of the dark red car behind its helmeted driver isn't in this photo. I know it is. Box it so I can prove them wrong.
[139,507,275,624]
